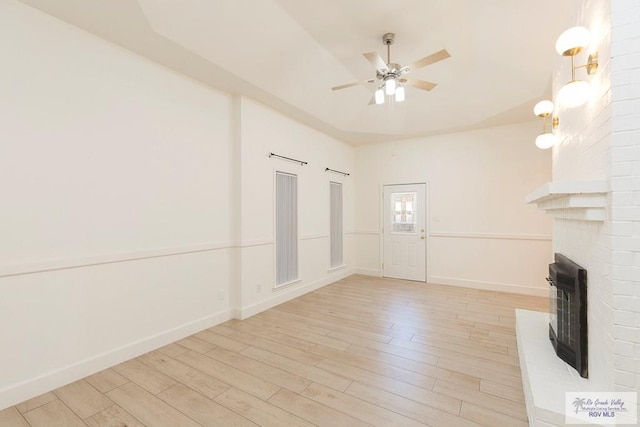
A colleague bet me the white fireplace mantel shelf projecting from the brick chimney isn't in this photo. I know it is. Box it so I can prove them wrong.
[525,181,609,221]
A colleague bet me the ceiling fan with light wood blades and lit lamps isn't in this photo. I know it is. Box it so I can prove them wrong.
[331,33,451,104]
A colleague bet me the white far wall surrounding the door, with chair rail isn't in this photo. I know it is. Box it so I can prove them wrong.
[355,122,551,295]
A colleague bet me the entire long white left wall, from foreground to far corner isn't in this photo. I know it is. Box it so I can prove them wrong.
[0,0,353,408]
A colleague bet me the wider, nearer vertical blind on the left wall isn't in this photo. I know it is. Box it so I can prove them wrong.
[276,172,298,286]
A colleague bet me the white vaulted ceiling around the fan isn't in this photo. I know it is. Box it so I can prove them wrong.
[22,0,581,144]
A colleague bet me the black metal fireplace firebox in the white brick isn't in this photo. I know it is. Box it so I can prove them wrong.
[547,253,589,378]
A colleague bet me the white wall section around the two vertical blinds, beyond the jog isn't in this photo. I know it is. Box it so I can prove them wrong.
[239,98,354,318]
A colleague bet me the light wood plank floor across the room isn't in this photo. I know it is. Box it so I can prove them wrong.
[0,275,547,427]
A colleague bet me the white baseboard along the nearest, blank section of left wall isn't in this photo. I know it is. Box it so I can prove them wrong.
[0,309,233,410]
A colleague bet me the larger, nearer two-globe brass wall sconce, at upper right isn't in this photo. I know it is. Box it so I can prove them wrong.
[556,27,598,108]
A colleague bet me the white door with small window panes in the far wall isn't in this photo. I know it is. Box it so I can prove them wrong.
[382,184,426,282]
